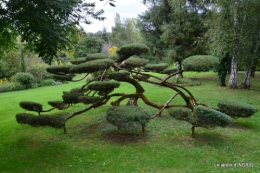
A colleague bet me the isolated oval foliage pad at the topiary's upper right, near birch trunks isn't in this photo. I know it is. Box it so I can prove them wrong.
[182,55,219,72]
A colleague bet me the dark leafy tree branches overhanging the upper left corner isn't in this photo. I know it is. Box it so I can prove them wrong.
[0,0,115,63]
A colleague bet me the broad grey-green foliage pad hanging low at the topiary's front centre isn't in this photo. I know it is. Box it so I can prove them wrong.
[106,106,152,131]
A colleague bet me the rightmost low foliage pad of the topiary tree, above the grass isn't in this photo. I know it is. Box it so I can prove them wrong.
[218,100,258,118]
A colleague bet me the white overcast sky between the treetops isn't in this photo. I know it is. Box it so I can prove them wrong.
[82,0,147,33]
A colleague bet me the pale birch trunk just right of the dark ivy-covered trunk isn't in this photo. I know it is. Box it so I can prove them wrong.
[228,49,238,89]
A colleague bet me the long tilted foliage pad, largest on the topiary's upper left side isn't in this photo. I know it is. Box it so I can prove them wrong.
[70,59,114,73]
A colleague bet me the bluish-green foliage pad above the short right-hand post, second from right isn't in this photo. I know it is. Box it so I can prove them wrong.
[193,106,231,127]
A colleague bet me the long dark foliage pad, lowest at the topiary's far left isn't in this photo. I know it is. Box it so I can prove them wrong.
[16,113,66,128]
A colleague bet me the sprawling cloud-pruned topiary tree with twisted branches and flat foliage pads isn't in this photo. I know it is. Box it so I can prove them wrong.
[16,44,258,136]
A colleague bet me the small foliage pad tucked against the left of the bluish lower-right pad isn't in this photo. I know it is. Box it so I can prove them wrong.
[168,107,192,120]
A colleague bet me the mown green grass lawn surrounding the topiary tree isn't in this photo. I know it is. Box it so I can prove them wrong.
[0,72,260,173]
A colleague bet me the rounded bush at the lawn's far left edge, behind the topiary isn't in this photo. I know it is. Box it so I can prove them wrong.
[14,73,35,89]
